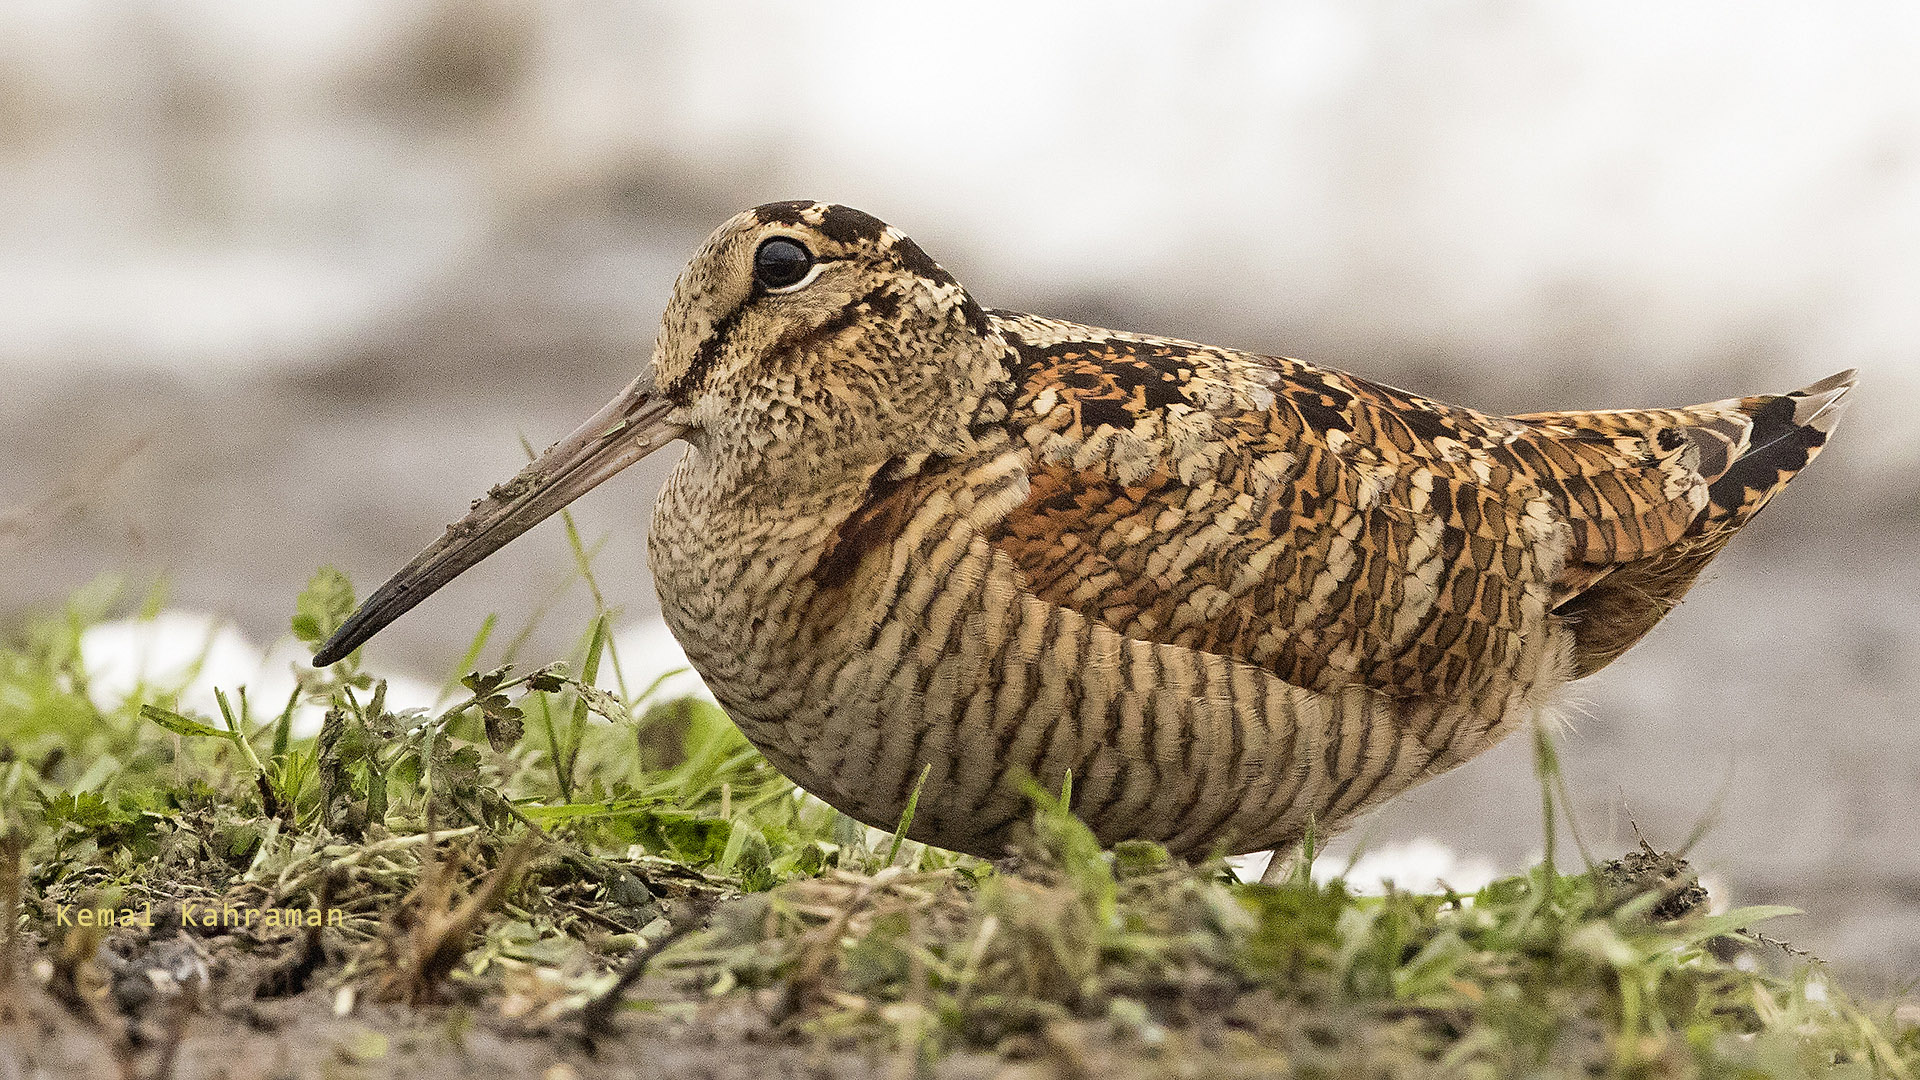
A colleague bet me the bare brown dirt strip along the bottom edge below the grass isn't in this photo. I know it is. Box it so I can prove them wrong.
[0,876,1413,1080]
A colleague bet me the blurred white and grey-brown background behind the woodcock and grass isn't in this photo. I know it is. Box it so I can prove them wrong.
[0,0,1920,976]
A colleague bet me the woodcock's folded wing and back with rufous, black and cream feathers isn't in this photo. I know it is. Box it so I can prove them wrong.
[967,313,1707,696]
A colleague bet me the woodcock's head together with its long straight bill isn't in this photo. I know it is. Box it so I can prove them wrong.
[315,202,1008,665]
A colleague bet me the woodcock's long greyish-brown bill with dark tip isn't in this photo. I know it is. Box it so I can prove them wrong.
[313,375,682,667]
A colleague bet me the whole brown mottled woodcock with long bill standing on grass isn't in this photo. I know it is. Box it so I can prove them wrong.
[315,202,1853,855]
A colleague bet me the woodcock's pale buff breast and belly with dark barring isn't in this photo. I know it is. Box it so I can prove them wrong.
[649,441,1559,855]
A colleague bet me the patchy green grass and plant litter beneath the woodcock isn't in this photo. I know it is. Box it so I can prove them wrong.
[0,568,1920,1078]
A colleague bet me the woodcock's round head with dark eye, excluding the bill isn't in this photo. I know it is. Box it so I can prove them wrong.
[653,202,1006,480]
